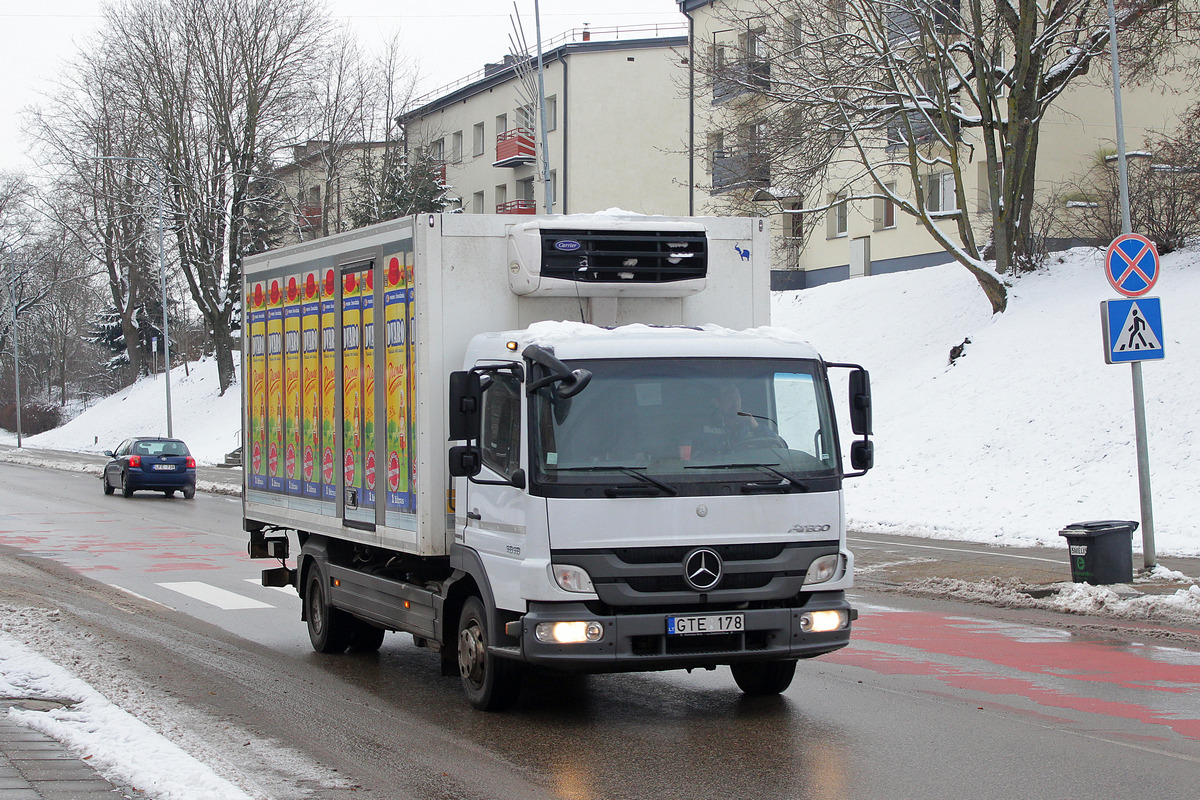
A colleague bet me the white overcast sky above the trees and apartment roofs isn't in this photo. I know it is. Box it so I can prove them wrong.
[0,0,685,172]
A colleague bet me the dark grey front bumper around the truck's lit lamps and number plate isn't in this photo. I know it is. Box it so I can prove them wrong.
[506,591,858,673]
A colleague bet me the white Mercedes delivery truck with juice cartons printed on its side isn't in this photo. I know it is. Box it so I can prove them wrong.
[242,213,872,710]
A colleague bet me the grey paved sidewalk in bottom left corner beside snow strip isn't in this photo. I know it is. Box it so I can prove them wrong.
[0,700,145,800]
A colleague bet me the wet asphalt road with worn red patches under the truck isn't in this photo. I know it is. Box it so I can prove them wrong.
[0,455,1200,800]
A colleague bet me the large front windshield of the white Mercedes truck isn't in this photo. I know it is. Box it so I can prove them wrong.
[529,359,840,497]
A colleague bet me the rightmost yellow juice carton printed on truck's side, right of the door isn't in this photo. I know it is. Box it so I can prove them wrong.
[384,253,412,511]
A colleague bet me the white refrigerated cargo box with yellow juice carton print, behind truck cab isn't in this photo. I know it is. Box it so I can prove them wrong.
[242,215,770,557]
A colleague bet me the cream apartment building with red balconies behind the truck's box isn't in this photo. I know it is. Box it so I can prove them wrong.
[400,26,689,215]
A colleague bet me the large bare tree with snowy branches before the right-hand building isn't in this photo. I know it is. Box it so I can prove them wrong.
[700,0,1192,312]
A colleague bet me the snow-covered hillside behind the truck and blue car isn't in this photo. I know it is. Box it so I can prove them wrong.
[4,244,1200,555]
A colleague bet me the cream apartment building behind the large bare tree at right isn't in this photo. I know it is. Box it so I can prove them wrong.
[679,0,1200,288]
